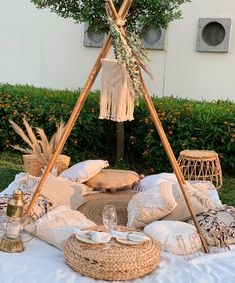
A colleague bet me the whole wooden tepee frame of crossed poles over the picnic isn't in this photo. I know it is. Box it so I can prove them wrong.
[27,0,209,253]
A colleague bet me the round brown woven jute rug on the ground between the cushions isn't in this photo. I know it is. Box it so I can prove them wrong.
[78,191,136,226]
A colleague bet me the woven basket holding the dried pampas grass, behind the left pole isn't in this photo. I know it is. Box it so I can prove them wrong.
[23,154,70,177]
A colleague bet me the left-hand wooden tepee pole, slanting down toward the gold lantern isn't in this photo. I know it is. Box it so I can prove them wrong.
[27,0,132,214]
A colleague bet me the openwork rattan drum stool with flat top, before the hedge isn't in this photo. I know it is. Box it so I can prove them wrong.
[178,150,222,189]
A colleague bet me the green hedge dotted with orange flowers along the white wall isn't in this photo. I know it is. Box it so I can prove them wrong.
[0,84,235,173]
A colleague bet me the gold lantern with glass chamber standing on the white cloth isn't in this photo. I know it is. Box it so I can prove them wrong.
[0,190,24,253]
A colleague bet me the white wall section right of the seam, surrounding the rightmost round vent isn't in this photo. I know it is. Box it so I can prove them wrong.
[164,0,235,100]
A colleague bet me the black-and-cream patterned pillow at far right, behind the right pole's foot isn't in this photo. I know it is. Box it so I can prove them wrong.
[187,205,235,247]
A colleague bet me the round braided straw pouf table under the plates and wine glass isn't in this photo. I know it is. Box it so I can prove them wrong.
[64,226,160,281]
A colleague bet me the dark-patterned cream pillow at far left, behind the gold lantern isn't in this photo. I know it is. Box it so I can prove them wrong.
[0,193,55,221]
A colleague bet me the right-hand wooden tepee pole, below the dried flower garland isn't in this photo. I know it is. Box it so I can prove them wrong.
[140,71,209,253]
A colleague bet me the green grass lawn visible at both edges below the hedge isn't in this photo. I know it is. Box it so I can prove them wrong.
[0,152,235,206]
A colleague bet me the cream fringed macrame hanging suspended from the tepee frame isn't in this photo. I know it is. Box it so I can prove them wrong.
[99,59,135,122]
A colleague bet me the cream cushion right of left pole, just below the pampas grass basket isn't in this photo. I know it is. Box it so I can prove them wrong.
[40,174,85,209]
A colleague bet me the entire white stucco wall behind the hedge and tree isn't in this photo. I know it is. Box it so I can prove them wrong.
[0,0,235,100]
